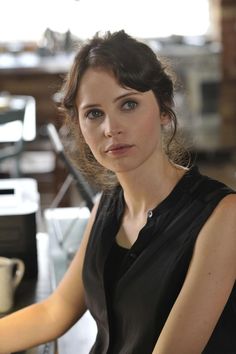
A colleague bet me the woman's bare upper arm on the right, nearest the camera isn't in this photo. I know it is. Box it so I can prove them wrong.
[153,195,236,354]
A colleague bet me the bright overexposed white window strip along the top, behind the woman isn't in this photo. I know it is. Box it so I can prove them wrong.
[0,0,209,42]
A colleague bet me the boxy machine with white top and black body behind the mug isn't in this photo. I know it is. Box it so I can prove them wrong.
[0,178,39,278]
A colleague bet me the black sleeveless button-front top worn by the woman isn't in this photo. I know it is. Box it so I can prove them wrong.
[83,167,236,354]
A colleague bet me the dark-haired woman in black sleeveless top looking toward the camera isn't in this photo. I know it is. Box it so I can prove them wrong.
[0,31,236,354]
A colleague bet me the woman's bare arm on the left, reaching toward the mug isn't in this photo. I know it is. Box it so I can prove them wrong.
[0,199,98,354]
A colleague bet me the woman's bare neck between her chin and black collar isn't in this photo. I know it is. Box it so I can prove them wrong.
[117,158,185,217]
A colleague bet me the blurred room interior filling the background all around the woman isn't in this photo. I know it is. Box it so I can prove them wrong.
[0,0,236,354]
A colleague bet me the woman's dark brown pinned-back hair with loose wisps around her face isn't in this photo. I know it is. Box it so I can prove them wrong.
[60,30,188,189]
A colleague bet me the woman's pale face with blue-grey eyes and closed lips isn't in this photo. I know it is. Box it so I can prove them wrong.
[76,68,168,173]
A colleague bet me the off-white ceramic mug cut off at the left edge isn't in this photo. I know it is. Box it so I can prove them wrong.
[0,257,25,313]
